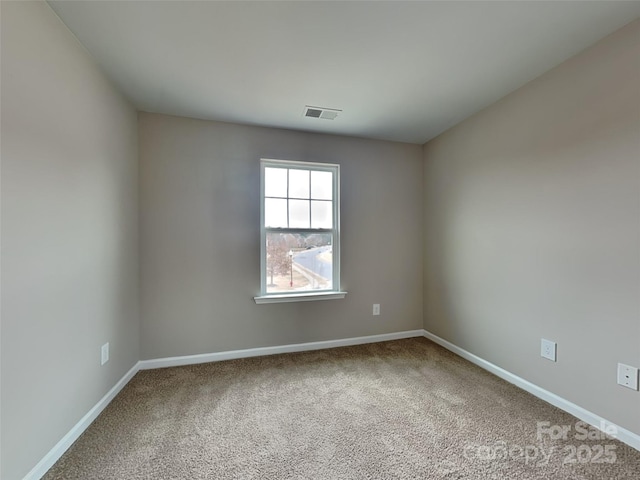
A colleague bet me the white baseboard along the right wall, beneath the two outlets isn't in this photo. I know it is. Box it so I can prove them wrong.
[424,330,640,450]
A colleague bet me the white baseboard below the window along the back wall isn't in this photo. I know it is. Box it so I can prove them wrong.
[139,330,424,370]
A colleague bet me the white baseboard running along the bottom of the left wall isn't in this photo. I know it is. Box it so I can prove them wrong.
[23,363,139,480]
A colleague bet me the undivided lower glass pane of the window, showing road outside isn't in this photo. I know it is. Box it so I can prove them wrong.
[265,233,333,293]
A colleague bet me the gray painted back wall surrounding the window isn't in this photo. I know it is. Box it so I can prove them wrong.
[138,113,423,359]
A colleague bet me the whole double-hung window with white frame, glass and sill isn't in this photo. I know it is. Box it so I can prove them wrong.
[255,159,345,303]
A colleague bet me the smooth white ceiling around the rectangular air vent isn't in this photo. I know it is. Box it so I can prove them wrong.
[49,0,640,144]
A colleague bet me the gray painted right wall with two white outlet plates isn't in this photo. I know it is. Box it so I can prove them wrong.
[424,21,640,434]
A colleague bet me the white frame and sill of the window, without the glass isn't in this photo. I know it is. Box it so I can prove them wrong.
[254,158,346,304]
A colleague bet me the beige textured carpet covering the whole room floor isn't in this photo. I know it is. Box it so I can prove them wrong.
[44,338,640,480]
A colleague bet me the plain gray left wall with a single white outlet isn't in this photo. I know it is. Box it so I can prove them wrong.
[0,2,139,480]
